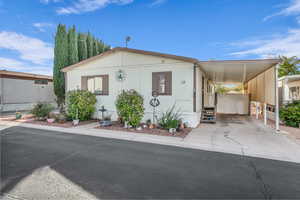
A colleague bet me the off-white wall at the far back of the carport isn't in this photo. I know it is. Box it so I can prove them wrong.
[217,94,249,115]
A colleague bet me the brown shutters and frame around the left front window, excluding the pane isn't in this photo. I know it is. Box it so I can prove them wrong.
[81,74,109,96]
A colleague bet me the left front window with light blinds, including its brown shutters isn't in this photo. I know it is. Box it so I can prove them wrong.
[81,75,109,95]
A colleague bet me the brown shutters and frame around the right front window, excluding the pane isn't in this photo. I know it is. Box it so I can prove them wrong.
[152,71,173,96]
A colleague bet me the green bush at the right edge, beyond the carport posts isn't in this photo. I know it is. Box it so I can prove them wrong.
[279,101,300,127]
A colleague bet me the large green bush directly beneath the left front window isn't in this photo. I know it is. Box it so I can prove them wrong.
[67,90,97,121]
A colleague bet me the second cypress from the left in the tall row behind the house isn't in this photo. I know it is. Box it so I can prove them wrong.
[68,26,79,65]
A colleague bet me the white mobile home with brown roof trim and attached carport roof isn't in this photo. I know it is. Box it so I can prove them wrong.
[62,47,279,127]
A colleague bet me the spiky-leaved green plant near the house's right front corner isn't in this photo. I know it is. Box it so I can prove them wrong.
[158,105,181,130]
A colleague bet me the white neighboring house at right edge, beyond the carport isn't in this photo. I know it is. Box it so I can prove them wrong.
[279,75,300,104]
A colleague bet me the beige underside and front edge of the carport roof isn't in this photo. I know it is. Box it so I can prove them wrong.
[198,59,280,83]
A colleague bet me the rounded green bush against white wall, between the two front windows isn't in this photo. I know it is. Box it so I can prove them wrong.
[116,90,145,127]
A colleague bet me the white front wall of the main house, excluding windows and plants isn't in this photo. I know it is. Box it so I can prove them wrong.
[66,52,200,126]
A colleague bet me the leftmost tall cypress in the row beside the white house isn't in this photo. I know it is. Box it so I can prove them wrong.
[53,24,69,110]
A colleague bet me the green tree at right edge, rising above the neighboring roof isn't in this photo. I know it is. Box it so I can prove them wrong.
[278,56,300,77]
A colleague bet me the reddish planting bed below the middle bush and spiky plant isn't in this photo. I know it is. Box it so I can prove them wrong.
[95,122,192,138]
